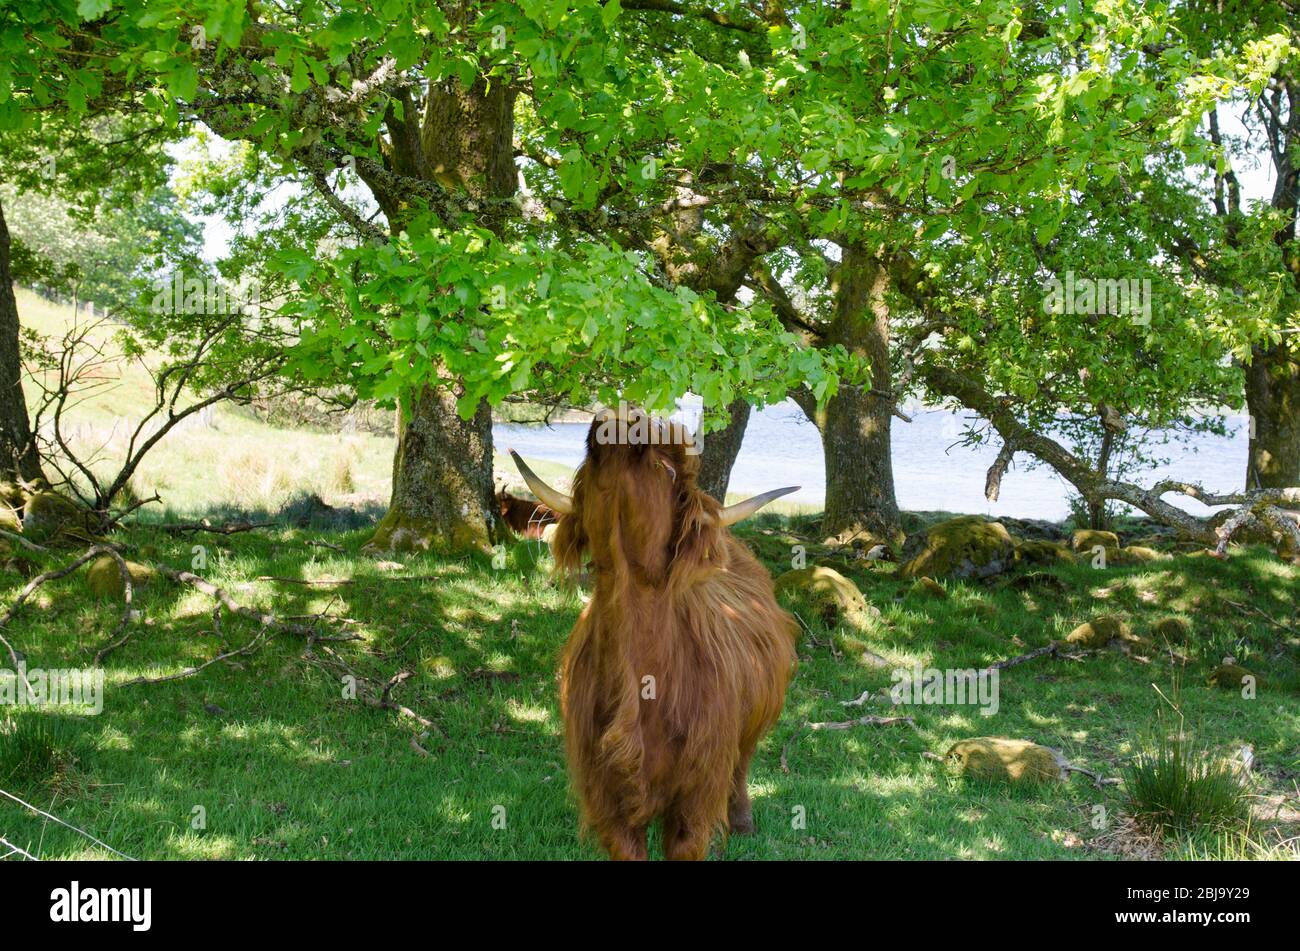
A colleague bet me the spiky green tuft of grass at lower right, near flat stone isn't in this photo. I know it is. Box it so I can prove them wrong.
[1123,722,1251,835]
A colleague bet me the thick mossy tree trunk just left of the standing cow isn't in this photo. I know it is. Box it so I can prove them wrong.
[367,77,516,551]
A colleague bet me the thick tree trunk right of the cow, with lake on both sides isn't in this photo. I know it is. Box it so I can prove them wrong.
[798,244,902,544]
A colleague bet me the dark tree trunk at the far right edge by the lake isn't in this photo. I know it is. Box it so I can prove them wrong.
[1245,338,1300,488]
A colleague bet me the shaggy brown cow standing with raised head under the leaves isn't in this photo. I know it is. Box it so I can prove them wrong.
[511,413,797,859]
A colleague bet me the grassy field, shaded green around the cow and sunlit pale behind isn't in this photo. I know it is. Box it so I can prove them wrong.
[0,285,1300,860]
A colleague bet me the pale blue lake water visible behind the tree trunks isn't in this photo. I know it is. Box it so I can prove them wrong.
[493,401,1248,521]
